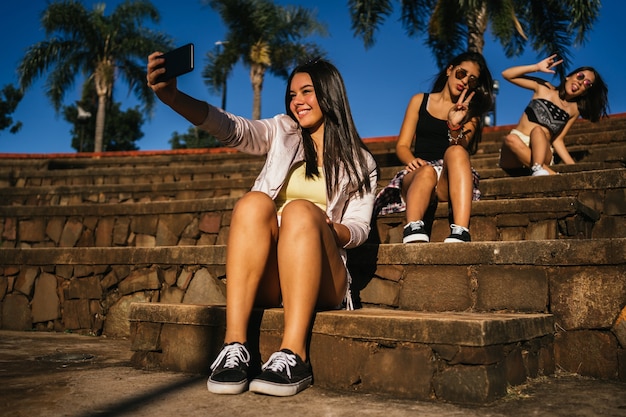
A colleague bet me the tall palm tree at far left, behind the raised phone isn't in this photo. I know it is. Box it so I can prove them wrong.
[18,0,172,152]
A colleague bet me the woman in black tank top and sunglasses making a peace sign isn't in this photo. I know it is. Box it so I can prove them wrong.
[375,52,493,243]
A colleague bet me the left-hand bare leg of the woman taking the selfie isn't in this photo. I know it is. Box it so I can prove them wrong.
[224,192,280,343]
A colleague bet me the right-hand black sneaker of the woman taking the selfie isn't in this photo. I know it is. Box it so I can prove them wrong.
[250,349,313,397]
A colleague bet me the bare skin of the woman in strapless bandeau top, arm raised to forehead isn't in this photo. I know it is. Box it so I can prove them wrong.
[499,55,595,174]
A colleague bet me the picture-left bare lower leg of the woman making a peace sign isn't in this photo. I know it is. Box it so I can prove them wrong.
[402,165,437,223]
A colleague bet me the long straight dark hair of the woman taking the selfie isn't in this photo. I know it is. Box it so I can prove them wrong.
[285,59,371,196]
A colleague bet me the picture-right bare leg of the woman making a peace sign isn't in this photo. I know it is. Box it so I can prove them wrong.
[437,146,474,228]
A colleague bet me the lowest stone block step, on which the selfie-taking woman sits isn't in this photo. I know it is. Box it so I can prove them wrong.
[130,303,555,404]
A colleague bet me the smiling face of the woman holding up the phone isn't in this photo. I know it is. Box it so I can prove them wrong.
[289,72,324,134]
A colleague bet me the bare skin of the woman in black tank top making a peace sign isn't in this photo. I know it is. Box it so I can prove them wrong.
[396,61,480,231]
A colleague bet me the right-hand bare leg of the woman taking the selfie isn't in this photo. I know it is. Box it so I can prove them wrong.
[278,200,347,360]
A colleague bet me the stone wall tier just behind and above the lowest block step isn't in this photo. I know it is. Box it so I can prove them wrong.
[0,239,626,380]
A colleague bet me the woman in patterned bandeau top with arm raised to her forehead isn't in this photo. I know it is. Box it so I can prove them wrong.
[499,54,608,176]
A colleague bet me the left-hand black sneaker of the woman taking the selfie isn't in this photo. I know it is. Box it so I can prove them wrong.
[207,342,250,394]
